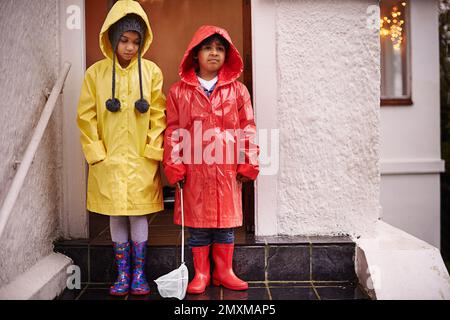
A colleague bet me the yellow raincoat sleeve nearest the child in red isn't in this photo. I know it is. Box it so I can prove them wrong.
[144,66,166,161]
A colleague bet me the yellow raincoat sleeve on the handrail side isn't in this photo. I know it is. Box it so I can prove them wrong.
[77,69,106,164]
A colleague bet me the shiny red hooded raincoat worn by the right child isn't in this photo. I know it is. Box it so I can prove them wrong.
[163,26,259,228]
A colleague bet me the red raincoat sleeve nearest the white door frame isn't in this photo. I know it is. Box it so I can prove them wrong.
[237,85,259,180]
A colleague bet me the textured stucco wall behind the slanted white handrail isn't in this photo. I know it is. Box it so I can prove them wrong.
[0,0,62,286]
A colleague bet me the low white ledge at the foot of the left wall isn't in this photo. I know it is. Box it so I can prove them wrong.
[0,253,72,300]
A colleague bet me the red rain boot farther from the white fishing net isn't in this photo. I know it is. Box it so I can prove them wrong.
[213,243,248,290]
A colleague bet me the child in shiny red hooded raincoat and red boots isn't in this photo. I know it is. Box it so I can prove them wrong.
[163,26,259,294]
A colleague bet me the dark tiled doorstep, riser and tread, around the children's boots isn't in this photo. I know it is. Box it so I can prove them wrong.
[55,229,368,300]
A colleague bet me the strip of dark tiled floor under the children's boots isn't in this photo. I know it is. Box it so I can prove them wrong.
[59,282,368,300]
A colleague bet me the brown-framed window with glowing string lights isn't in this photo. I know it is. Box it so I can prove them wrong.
[380,0,412,106]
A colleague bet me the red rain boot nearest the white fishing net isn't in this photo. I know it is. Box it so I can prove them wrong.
[187,245,211,294]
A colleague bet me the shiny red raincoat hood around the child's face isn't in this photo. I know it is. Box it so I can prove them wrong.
[178,26,244,85]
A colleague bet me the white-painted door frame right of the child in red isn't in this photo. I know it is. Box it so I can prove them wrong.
[251,0,278,236]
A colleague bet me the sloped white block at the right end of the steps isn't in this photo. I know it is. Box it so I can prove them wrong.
[355,221,450,300]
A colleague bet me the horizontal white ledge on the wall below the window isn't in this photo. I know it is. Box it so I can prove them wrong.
[380,159,445,175]
